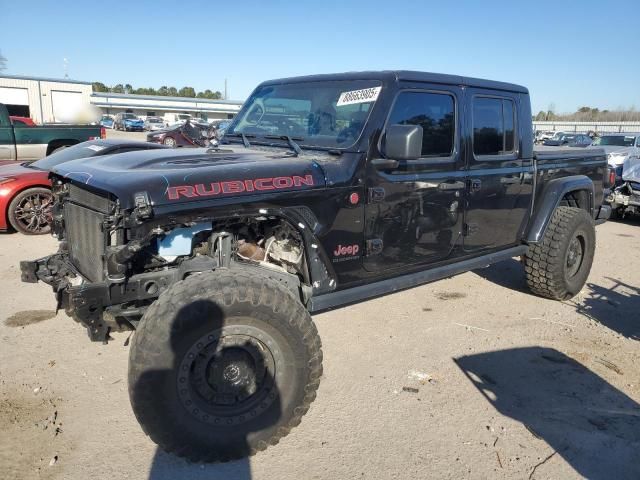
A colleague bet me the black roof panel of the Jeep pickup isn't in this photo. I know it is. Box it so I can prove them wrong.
[262,70,529,93]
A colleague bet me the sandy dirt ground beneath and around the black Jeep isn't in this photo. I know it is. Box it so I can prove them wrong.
[0,221,640,480]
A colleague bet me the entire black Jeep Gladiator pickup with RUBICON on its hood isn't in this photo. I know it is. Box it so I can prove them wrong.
[21,71,610,461]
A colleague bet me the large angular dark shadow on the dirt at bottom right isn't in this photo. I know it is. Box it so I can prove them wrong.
[454,347,640,480]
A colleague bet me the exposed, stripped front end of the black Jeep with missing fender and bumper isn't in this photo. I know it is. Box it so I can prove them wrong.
[20,179,322,342]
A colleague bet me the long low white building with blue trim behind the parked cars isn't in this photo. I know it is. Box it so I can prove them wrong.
[0,75,243,123]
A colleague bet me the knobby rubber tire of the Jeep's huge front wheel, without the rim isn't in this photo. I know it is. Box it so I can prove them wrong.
[129,269,322,462]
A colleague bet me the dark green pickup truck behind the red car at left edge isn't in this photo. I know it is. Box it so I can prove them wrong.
[0,103,105,160]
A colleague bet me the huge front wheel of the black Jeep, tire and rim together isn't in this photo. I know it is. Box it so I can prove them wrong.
[129,270,322,462]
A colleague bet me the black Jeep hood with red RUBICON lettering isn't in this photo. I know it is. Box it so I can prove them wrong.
[53,147,326,208]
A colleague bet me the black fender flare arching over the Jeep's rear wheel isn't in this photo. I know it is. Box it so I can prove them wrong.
[525,175,595,244]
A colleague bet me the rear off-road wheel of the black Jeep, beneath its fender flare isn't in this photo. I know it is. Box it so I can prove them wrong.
[523,206,596,300]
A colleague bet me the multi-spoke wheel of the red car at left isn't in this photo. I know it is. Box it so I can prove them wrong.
[8,188,53,235]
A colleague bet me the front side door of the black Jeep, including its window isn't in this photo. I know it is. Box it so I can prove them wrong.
[364,84,466,271]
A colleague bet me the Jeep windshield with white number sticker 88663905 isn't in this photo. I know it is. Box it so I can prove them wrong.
[225,80,381,148]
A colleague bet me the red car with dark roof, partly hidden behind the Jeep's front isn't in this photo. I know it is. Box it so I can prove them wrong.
[0,139,167,235]
